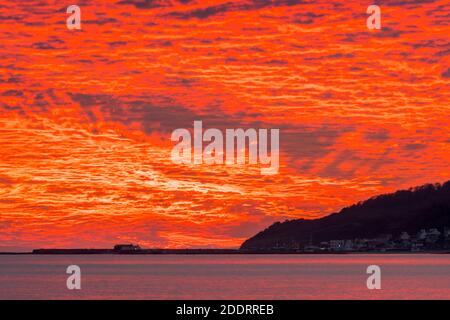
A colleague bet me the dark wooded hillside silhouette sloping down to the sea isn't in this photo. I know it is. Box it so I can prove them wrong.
[241,181,450,251]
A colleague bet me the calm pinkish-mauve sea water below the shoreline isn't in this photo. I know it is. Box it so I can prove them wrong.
[0,254,450,299]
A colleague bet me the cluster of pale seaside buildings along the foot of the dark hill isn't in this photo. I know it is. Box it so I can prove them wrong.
[303,228,450,252]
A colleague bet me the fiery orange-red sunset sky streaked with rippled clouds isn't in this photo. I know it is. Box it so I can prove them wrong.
[0,0,450,251]
